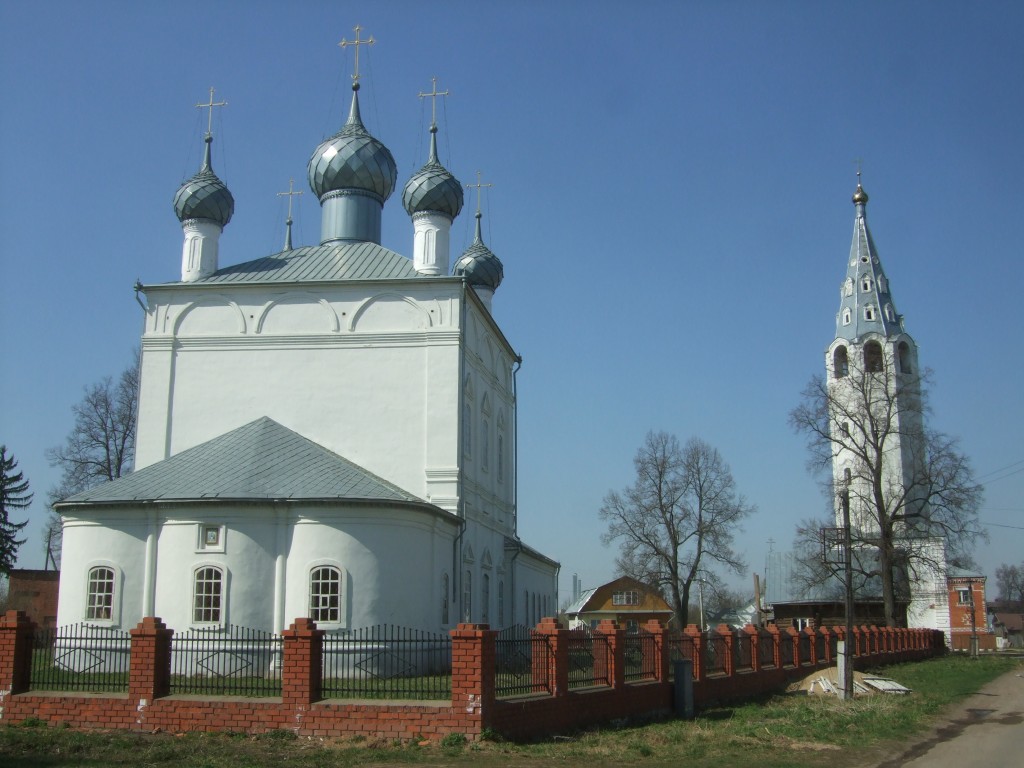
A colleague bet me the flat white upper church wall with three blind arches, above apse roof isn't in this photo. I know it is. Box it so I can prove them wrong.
[136,283,468,511]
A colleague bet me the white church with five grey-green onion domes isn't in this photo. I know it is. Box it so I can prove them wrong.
[56,37,559,632]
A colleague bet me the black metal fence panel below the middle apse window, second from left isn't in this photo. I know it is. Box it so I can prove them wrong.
[170,625,284,696]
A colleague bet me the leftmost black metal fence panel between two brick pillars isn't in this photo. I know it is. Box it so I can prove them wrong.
[29,624,131,691]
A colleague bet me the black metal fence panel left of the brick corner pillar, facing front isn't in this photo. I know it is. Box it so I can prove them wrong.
[321,625,452,699]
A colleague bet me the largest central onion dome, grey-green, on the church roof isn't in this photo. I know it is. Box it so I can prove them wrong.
[307,83,398,205]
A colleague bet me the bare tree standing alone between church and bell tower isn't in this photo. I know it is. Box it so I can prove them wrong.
[599,432,755,625]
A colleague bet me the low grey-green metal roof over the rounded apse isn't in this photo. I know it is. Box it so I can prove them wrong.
[59,417,424,507]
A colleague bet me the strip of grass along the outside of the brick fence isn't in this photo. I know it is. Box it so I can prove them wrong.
[0,656,1024,768]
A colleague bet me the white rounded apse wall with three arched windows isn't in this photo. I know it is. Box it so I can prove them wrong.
[58,502,458,632]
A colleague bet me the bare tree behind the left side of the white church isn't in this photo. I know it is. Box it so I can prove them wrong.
[46,352,139,558]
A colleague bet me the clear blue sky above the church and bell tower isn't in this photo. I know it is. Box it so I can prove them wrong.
[0,0,1024,599]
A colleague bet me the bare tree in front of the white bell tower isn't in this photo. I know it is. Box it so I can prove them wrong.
[790,353,984,626]
